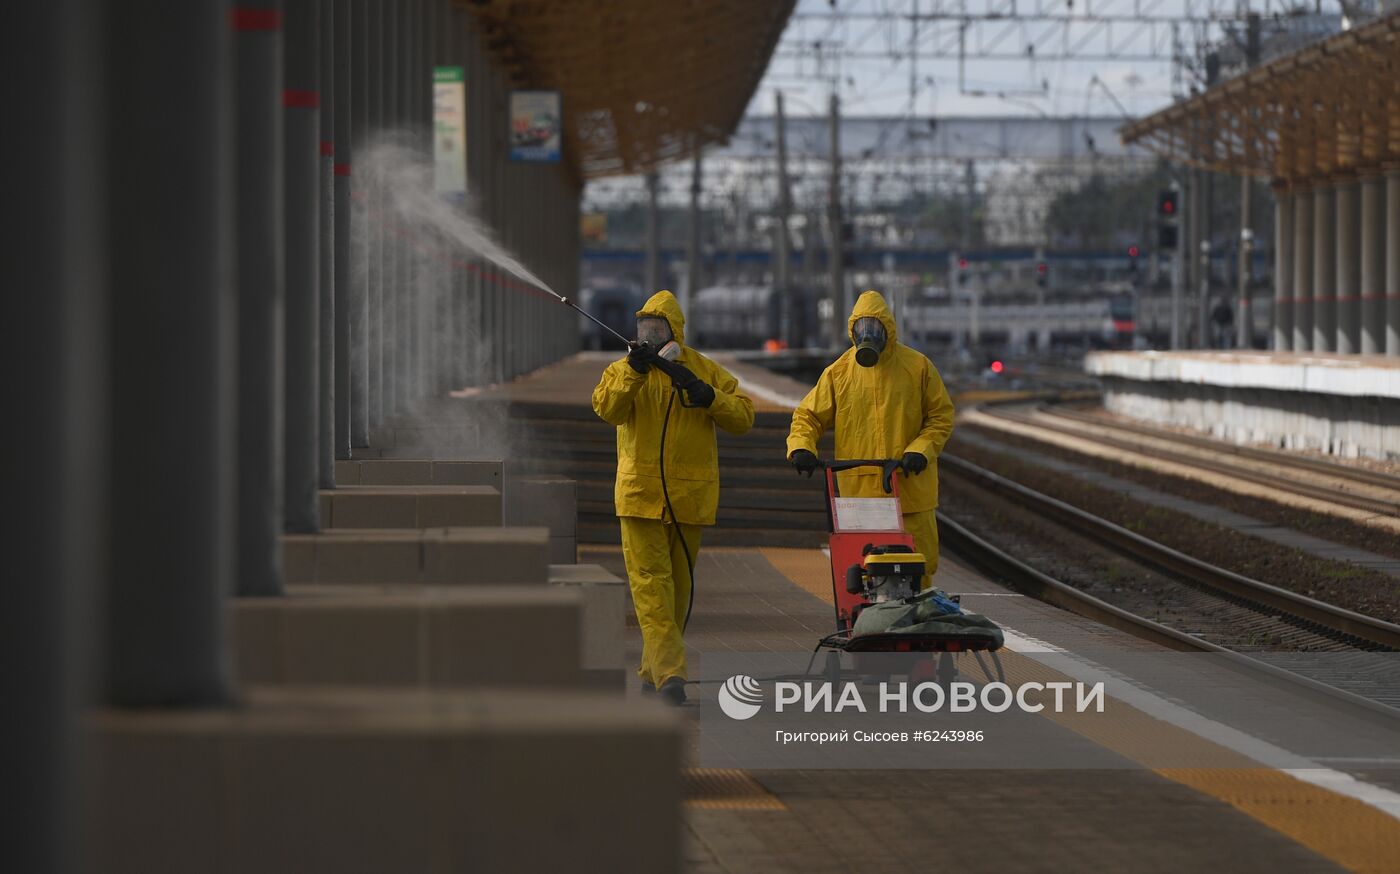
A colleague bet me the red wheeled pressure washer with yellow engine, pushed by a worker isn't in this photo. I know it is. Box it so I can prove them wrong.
[806,459,1005,685]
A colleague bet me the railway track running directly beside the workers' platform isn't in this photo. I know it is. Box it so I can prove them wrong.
[939,454,1400,719]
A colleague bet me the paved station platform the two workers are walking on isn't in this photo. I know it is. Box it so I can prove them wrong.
[468,353,1400,874]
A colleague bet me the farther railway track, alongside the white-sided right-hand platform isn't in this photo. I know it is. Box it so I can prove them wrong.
[980,403,1400,517]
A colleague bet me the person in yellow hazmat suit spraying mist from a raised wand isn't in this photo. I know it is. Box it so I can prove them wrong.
[594,291,753,705]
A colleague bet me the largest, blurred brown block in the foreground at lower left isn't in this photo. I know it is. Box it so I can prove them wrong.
[91,688,682,874]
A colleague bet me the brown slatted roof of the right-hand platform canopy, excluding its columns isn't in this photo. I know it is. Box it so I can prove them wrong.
[1120,14,1400,182]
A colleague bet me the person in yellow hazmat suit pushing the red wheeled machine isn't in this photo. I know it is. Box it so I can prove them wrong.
[787,291,953,588]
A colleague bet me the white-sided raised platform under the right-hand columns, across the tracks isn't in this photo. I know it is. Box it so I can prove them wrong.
[1084,352,1400,461]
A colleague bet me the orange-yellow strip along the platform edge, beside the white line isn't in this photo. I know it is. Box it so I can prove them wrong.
[762,548,1400,874]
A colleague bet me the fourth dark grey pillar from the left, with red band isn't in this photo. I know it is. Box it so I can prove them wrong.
[283,0,323,532]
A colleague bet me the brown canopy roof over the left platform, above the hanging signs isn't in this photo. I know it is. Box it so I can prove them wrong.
[462,0,795,179]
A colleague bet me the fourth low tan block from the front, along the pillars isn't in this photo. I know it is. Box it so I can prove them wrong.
[321,485,501,528]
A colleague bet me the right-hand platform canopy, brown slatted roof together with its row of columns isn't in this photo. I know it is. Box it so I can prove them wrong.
[1120,13,1400,356]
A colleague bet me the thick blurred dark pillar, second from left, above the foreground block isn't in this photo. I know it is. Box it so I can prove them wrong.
[106,0,232,703]
